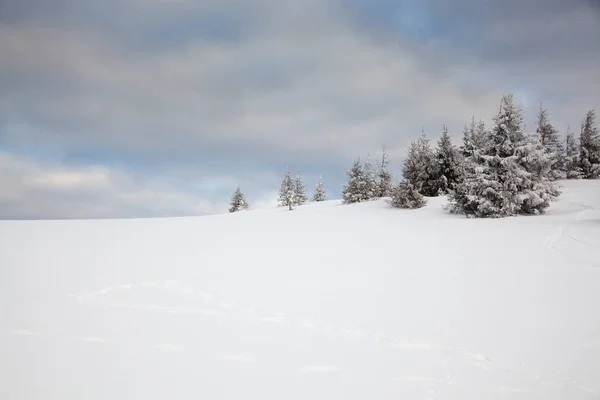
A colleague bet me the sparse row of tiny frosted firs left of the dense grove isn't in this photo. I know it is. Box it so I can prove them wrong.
[229,169,327,213]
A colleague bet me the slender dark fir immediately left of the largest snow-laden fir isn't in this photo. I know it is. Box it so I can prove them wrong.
[435,125,463,194]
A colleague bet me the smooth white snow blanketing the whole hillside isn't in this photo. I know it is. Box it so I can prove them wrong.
[0,181,600,400]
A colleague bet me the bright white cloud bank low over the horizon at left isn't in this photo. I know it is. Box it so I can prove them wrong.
[0,153,230,218]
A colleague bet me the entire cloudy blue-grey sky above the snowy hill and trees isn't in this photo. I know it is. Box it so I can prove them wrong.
[0,0,600,218]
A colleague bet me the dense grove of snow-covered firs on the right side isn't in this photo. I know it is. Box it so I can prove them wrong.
[343,93,600,217]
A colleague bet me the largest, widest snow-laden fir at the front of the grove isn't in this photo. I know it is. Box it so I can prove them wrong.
[447,93,560,217]
